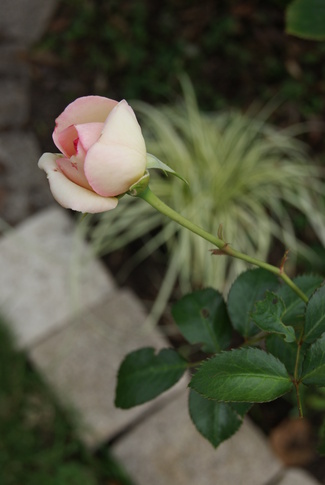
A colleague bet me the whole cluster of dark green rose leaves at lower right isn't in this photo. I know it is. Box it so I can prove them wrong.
[116,268,325,450]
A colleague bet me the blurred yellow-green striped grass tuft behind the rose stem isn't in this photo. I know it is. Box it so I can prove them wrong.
[84,78,325,322]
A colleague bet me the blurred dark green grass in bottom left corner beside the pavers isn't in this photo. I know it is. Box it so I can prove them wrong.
[0,316,132,485]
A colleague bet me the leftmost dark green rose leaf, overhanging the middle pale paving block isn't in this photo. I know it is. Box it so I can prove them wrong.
[115,348,187,409]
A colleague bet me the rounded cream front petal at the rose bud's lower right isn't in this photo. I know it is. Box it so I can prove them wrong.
[84,143,145,197]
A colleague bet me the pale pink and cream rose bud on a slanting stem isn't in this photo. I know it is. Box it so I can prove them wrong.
[38,96,147,213]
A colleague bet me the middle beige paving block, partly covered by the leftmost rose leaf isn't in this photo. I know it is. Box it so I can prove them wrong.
[30,290,187,448]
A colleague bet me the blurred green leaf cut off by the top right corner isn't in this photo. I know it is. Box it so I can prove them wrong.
[286,0,325,40]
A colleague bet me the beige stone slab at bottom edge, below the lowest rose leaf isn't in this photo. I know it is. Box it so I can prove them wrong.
[112,395,281,485]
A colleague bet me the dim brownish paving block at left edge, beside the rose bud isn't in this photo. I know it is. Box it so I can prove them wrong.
[0,131,53,224]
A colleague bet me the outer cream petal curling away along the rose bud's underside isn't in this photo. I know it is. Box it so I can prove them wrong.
[38,153,118,214]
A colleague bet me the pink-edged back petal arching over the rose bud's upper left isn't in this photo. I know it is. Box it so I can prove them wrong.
[53,96,118,150]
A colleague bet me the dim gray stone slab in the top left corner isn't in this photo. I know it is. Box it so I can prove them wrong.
[0,0,58,45]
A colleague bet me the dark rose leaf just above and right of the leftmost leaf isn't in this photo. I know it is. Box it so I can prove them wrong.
[172,288,232,353]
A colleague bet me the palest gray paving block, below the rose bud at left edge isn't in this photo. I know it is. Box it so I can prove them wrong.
[0,207,115,347]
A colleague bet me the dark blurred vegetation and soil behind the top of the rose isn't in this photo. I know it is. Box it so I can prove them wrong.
[32,0,325,152]
